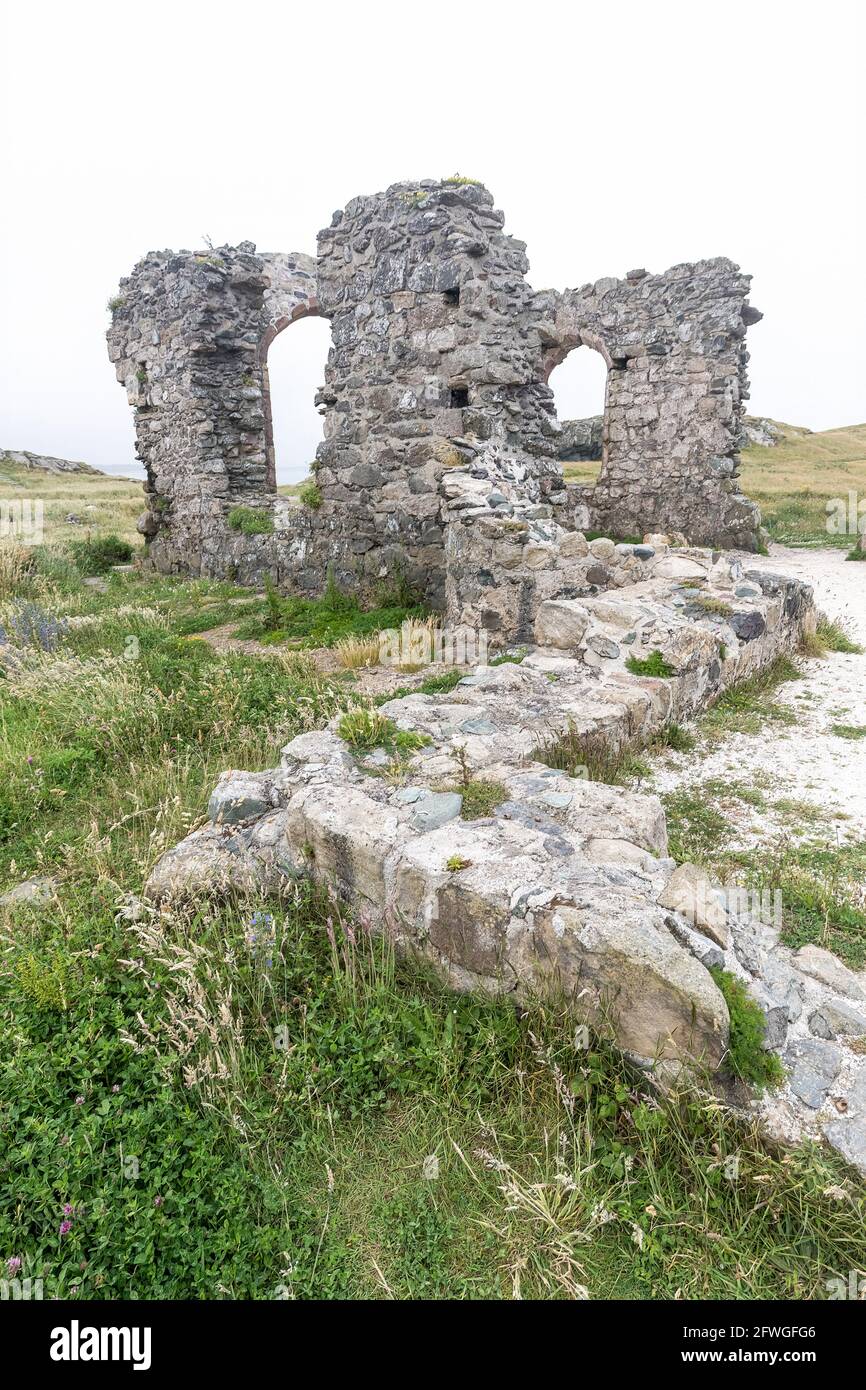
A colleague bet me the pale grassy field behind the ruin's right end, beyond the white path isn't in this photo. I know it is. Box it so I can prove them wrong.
[563,423,866,550]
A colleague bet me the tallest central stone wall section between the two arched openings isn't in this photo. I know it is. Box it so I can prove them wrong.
[316,182,562,602]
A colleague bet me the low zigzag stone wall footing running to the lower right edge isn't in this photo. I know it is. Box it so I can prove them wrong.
[147,550,866,1172]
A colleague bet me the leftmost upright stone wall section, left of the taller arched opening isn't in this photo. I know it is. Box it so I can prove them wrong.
[108,242,318,575]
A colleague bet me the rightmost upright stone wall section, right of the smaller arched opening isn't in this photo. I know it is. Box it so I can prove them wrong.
[548,257,762,549]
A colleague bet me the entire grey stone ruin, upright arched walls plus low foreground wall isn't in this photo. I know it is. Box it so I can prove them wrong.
[108,173,866,1170]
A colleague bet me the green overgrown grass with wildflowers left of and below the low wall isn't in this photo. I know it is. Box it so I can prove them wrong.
[0,461,866,1300]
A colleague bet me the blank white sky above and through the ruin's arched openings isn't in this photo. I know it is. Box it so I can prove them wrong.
[0,0,866,478]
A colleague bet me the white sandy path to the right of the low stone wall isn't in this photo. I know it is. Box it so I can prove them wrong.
[652,546,866,844]
